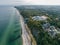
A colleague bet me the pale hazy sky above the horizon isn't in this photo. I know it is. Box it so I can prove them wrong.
[0,0,60,5]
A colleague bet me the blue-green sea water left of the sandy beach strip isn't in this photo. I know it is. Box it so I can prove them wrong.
[0,6,22,45]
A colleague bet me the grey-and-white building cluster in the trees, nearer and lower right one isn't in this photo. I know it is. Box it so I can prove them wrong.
[42,23,60,37]
